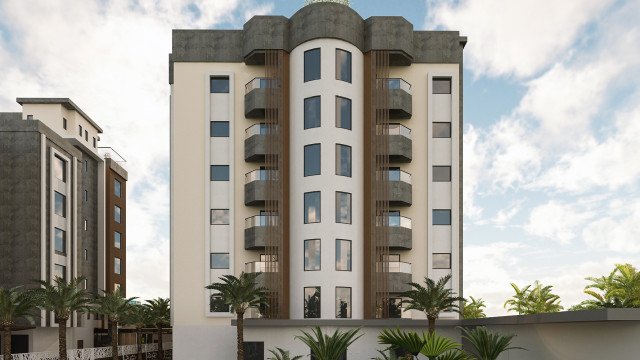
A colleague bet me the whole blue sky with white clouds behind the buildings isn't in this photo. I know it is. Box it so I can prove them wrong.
[0,0,640,315]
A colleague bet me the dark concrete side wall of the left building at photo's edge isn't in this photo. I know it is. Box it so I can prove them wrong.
[0,129,41,287]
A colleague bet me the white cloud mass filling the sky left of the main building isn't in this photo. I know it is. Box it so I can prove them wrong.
[0,0,272,298]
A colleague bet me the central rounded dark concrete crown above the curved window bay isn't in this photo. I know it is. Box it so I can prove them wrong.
[289,3,364,50]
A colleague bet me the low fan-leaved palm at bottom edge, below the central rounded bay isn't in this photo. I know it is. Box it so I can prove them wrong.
[296,326,363,360]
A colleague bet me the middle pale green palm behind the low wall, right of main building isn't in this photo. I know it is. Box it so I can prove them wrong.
[504,280,562,315]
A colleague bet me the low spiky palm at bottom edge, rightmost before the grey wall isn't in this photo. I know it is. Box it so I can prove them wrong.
[460,326,526,360]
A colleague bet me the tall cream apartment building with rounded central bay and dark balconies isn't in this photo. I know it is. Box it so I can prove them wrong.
[169,3,466,359]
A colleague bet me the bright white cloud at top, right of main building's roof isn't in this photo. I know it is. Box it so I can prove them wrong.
[427,0,613,77]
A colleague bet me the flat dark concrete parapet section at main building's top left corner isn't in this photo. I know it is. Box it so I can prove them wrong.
[171,30,243,62]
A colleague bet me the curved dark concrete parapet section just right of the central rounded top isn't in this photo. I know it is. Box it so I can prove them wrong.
[364,16,414,58]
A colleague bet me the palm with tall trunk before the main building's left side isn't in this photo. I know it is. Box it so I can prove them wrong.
[206,272,268,360]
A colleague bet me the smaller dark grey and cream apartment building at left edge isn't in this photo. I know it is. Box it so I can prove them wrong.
[0,98,127,352]
